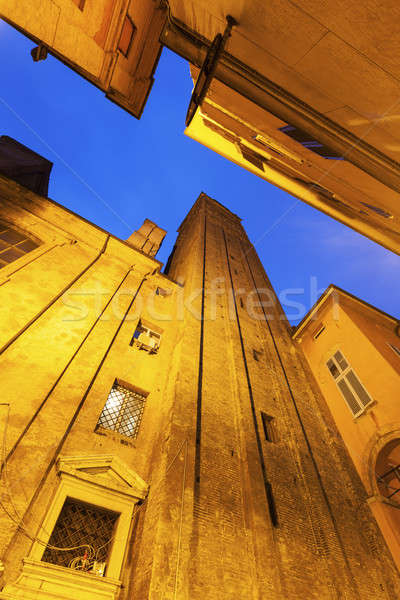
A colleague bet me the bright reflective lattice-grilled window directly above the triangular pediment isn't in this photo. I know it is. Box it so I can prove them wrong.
[97,381,146,438]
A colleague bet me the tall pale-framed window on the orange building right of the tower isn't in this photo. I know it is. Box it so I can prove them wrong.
[326,350,372,416]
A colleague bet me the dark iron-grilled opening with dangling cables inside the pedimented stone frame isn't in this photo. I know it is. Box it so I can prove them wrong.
[42,498,119,571]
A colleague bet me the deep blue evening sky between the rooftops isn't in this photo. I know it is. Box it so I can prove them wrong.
[0,21,400,323]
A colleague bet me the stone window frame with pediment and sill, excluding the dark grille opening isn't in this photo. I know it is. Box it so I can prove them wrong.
[0,455,148,600]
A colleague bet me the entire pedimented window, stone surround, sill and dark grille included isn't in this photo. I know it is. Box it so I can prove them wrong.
[0,455,148,600]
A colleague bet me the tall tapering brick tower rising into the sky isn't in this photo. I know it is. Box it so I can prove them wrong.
[135,193,399,600]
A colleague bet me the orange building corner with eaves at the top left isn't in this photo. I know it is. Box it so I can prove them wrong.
[0,0,166,119]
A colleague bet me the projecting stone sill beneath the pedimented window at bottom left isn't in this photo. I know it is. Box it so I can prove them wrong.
[0,558,121,600]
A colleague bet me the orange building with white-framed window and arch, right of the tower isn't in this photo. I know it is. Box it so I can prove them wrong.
[293,285,400,568]
